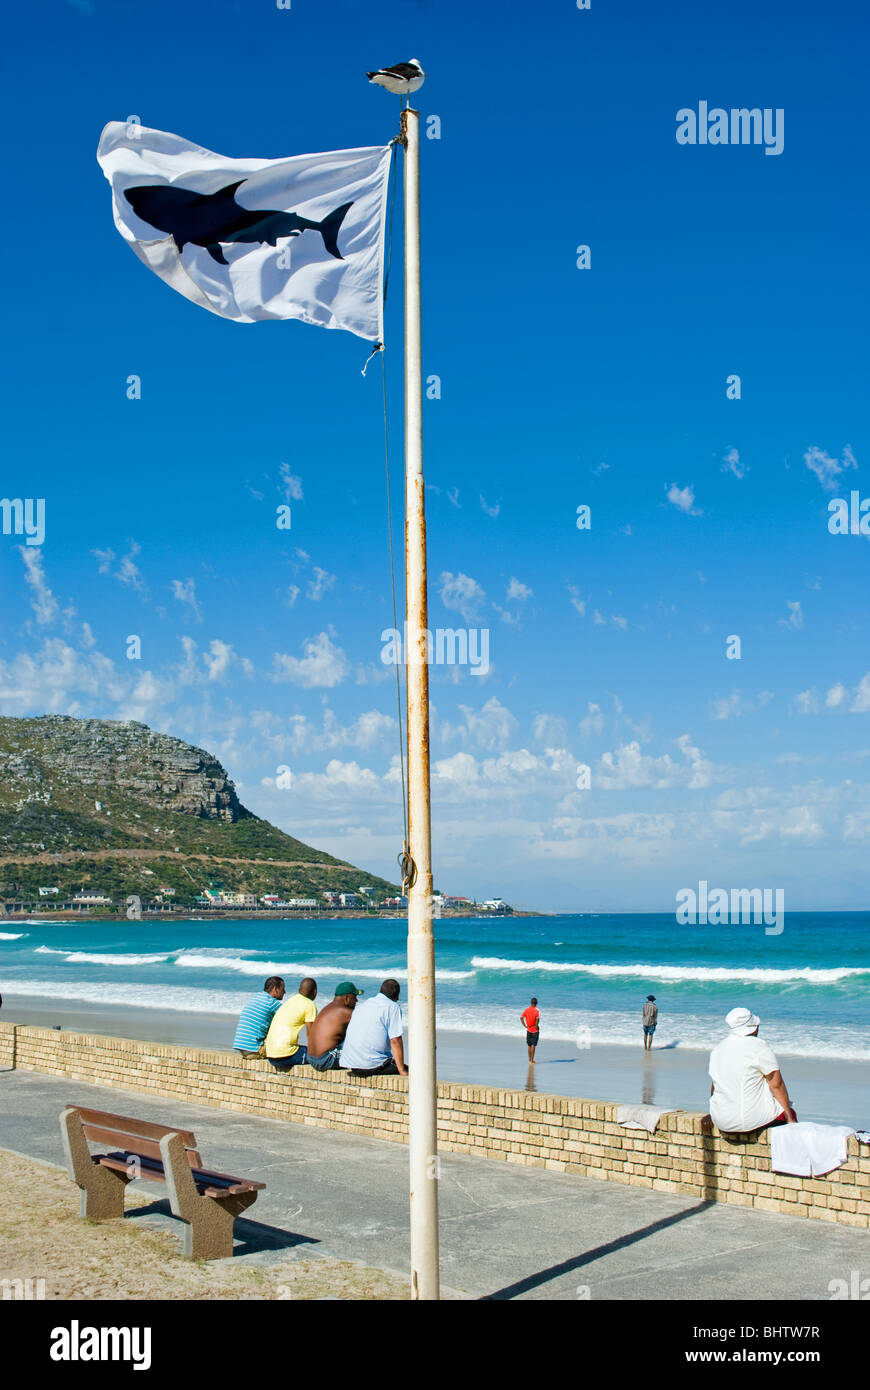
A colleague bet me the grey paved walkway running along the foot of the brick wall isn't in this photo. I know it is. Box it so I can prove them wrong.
[0,1072,870,1301]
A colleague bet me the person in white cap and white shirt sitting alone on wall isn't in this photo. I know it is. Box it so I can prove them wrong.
[710,1009,798,1134]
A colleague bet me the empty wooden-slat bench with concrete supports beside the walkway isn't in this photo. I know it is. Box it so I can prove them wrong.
[60,1105,265,1259]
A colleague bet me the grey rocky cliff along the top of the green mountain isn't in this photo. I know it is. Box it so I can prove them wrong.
[0,714,244,823]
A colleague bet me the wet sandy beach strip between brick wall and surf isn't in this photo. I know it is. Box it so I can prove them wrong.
[0,997,870,1129]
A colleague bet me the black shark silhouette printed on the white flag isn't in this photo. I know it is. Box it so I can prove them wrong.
[124,179,353,265]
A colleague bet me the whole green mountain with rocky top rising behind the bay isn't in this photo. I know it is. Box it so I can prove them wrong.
[0,714,397,908]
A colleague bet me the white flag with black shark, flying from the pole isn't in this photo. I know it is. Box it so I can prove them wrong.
[97,121,391,342]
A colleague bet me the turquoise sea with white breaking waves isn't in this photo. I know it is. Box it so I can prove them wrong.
[0,912,870,1061]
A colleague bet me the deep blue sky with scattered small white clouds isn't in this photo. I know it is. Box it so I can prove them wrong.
[0,0,870,910]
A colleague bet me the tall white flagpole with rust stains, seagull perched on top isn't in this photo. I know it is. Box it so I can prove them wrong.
[402,108,439,1300]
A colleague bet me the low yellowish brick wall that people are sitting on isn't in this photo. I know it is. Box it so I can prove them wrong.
[0,1023,870,1229]
